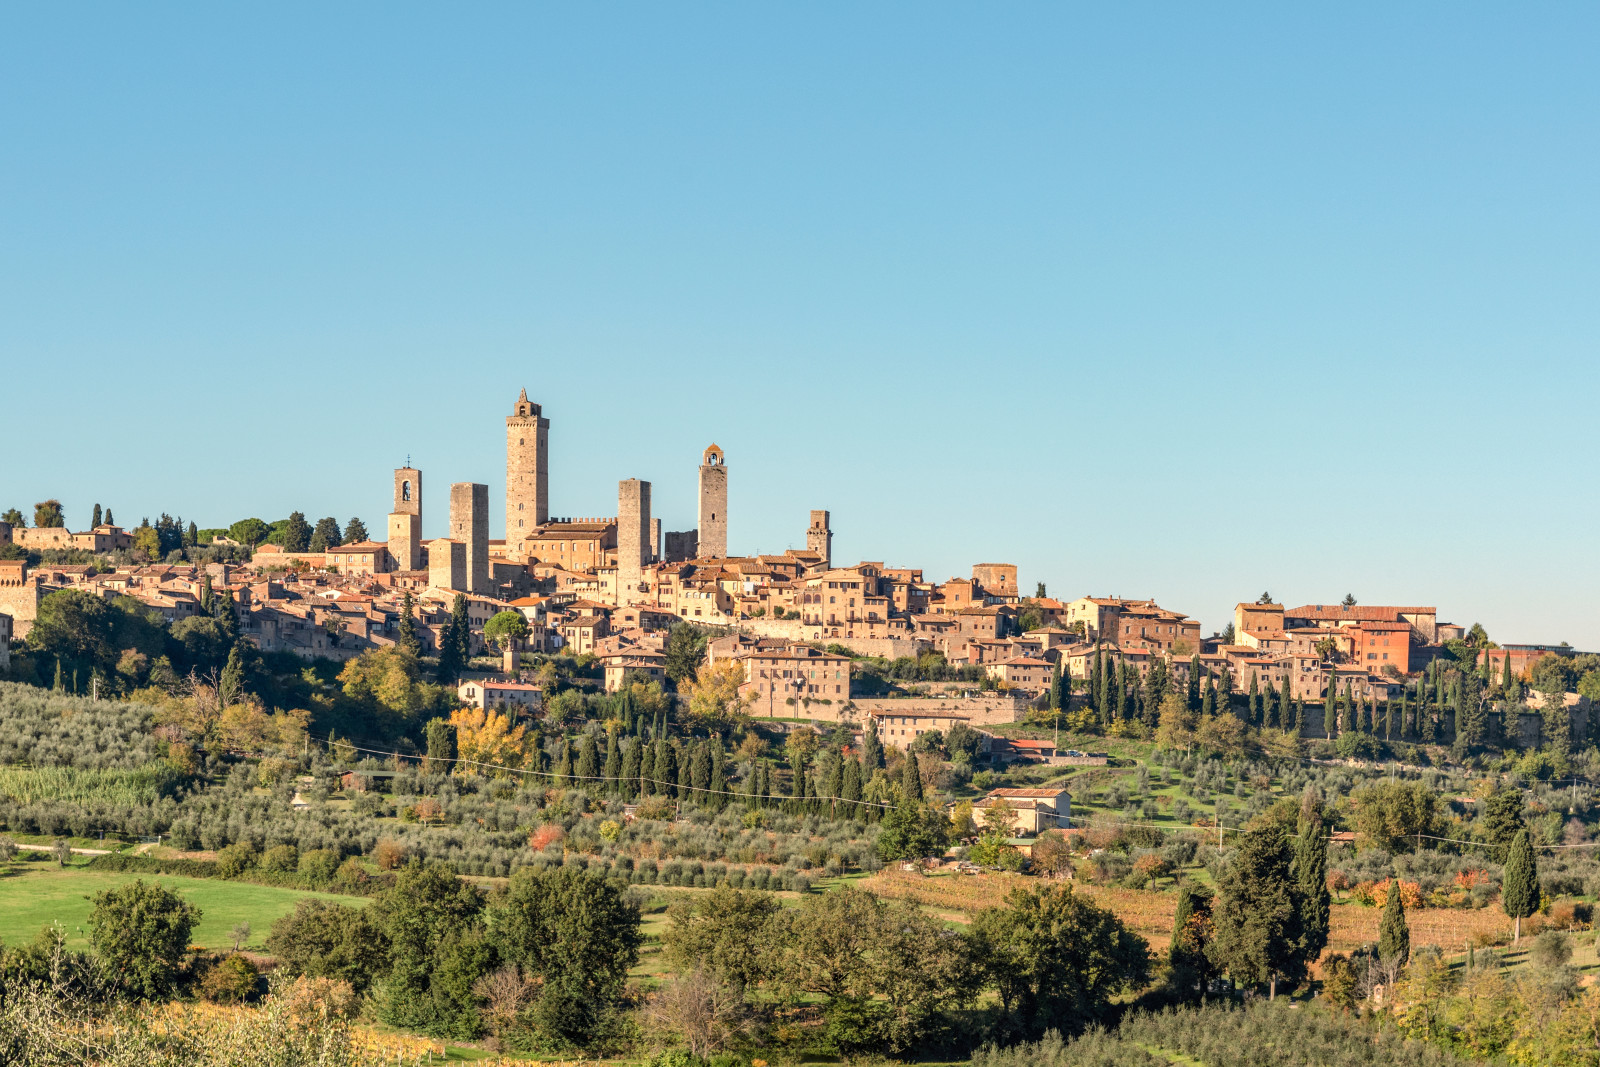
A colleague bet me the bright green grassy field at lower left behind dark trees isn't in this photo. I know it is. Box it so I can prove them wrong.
[0,864,368,949]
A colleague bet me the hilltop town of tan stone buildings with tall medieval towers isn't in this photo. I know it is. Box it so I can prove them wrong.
[0,390,1590,764]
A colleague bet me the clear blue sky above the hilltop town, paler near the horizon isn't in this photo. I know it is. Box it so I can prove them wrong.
[0,3,1600,648]
